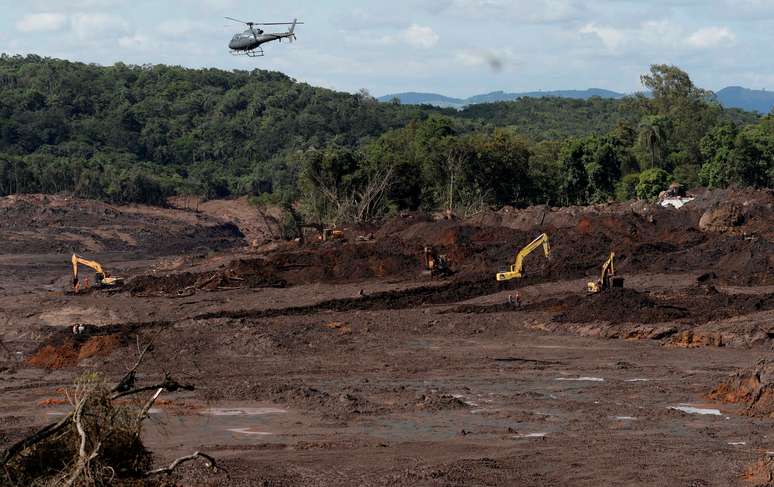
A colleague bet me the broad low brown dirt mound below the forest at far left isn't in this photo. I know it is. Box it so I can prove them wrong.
[0,195,245,255]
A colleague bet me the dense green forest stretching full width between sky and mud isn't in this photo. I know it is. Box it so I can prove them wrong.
[0,55,774,228]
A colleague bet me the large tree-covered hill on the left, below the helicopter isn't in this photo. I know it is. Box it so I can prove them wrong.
[0,56,454,202]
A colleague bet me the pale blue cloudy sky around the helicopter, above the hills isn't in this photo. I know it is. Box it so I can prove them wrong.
[0,0,774,97]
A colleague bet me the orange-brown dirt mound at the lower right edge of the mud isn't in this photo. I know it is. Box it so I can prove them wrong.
[707,360,774,417]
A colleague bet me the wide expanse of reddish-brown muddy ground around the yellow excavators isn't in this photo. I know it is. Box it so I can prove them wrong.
[0,191,774,486]
